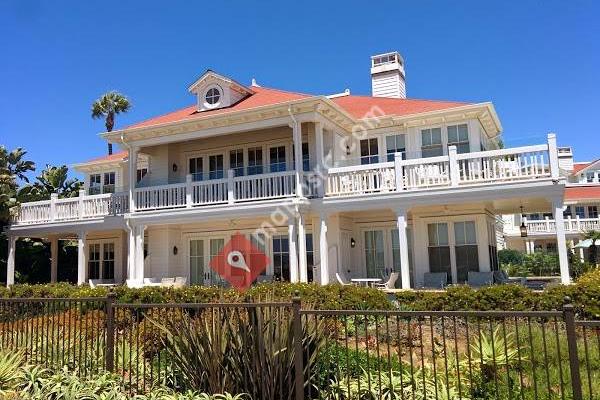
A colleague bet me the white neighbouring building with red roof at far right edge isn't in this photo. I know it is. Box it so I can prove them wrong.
[503,147,600,260]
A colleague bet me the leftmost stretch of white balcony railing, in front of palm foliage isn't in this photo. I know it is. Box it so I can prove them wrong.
[13,190,129,225]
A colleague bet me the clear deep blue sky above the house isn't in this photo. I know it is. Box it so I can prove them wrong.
[0,0,600,178]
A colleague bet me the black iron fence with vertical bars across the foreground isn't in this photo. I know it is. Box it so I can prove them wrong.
[0,294,600,400]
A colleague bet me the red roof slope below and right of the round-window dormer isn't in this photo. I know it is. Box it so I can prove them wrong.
[128,86,310,128]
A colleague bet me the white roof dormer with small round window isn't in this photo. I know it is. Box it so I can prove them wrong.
[188,70,254,111]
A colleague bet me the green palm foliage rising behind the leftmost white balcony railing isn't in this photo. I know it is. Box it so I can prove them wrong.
[18,165,83,201]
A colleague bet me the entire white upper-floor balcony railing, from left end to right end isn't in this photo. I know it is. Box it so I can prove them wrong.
[13,137,559,225]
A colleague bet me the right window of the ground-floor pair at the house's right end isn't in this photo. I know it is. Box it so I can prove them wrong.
[454,221,479,283]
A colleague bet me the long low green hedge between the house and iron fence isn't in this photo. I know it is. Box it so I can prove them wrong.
[0,269,600,319]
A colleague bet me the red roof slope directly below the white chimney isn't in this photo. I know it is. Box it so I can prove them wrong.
[332,96,469,118]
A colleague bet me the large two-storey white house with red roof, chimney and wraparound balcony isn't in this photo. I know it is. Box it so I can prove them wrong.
[7,52,569,288]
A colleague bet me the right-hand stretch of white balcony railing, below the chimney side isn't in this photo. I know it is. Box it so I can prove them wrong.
[325,135,559,197]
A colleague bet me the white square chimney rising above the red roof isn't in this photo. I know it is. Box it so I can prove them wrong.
[371,51,406,99]
